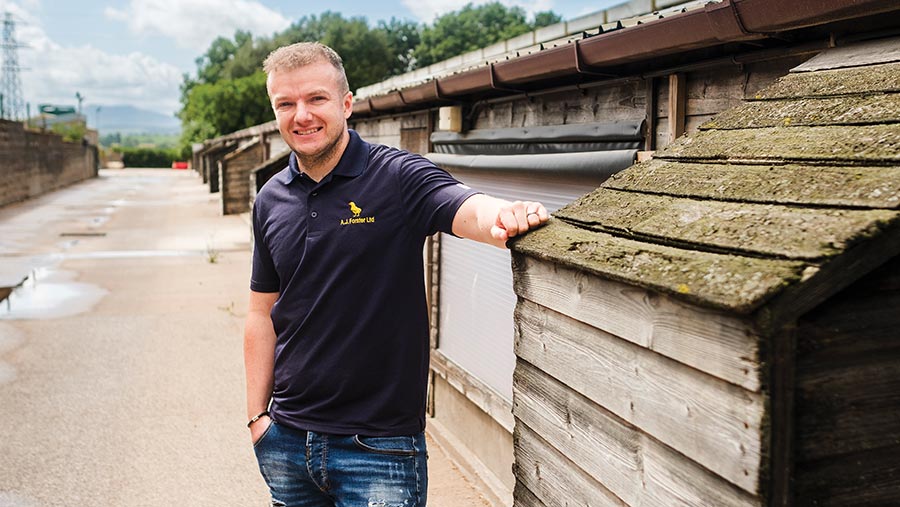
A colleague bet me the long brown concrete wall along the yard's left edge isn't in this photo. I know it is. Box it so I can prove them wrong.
[0,120,98,206]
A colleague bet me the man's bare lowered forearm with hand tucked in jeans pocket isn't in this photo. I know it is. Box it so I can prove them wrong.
[244,291,278,442]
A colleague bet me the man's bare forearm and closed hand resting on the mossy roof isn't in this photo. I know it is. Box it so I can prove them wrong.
[453,194,550,248]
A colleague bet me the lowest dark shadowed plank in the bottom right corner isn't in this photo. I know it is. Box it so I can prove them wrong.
[794,444,900,507]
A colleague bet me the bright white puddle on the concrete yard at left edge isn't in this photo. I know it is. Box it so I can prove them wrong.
[0,267,107,320]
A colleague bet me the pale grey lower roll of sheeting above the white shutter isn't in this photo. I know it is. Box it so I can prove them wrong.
[425,150,637,180]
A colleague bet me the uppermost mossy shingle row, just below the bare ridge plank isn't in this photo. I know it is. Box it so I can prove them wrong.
[754,63,900,100]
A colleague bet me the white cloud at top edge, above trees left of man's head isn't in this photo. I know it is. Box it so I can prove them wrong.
[104,0,291,52]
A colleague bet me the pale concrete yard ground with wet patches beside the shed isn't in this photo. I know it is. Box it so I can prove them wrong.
[0,169,484,507]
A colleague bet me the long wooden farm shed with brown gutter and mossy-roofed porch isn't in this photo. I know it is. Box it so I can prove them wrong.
[194,0,900,506]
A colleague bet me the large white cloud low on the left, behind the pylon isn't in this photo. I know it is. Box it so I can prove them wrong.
[0,0,182,114]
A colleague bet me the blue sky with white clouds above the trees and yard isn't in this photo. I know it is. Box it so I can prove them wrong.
[0,0,625,124]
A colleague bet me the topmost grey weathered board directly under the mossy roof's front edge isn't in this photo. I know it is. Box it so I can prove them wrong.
[515,256,761,392]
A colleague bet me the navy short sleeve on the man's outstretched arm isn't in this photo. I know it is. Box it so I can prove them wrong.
[398,154,479,236]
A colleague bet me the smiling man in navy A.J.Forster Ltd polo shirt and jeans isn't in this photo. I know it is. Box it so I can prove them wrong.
[244,43,548,507]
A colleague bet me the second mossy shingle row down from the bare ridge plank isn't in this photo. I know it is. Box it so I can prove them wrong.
[700,93,900,130]
